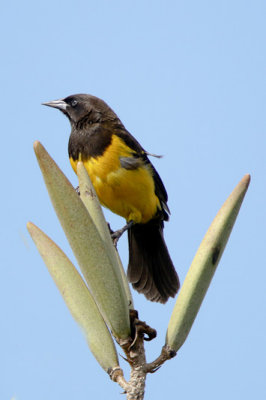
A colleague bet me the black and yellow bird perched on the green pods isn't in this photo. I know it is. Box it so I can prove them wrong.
[44,94,179,303]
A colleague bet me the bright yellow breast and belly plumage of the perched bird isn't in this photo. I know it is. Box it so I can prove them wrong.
[70,135,161,223]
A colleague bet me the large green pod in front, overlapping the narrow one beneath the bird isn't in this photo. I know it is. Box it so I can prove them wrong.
[34,141,130,339]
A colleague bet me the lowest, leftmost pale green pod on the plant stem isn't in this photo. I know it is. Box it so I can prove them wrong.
[27,222,119,372]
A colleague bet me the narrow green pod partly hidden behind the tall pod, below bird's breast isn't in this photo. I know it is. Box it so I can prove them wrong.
[77,161,134,309]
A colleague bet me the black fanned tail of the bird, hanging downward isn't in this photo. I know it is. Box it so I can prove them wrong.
[127,219,180,303]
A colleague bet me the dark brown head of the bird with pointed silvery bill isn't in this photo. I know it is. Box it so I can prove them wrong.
[43,94,117,125]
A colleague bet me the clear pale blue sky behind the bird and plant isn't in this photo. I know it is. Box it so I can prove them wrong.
[0,0,266,400]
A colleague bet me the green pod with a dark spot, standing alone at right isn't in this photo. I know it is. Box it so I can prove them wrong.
[166,175,250,351]
